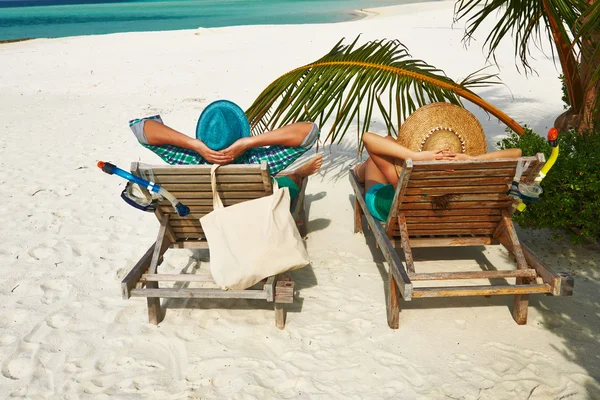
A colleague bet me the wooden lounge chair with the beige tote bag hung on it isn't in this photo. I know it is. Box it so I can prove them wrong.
[121,162,307,329]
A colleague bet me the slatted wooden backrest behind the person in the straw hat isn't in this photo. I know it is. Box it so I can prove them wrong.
[387,154,545,237]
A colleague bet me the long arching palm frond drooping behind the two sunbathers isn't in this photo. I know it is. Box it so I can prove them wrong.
[246,38,523,142]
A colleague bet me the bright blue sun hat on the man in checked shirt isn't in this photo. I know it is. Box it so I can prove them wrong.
[196,100,250,151]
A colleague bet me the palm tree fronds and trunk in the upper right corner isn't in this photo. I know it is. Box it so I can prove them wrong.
[455,0,600,129]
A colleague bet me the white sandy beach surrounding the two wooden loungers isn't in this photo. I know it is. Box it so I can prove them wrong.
[0,2,600,399]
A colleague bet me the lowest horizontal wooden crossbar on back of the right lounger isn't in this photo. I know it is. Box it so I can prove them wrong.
[413,283,550,298]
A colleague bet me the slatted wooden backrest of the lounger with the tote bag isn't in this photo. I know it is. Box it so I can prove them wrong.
[131,162,273,241]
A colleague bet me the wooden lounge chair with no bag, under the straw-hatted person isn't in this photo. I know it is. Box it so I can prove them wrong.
[350,154,573,329]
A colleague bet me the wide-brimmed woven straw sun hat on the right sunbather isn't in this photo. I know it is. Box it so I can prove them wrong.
[396,103,487,172]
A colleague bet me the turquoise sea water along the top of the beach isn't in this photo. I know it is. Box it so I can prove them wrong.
[0,0,432,40]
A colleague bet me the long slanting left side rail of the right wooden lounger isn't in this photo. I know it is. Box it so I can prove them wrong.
[348,170,412,301]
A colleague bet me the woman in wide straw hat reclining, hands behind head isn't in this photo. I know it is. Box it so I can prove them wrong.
[354,103,521,221]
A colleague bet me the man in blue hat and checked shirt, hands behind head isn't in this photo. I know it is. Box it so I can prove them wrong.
[129,100,322,197]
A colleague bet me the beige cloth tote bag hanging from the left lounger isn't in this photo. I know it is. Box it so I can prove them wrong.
[200,164,309,290]
